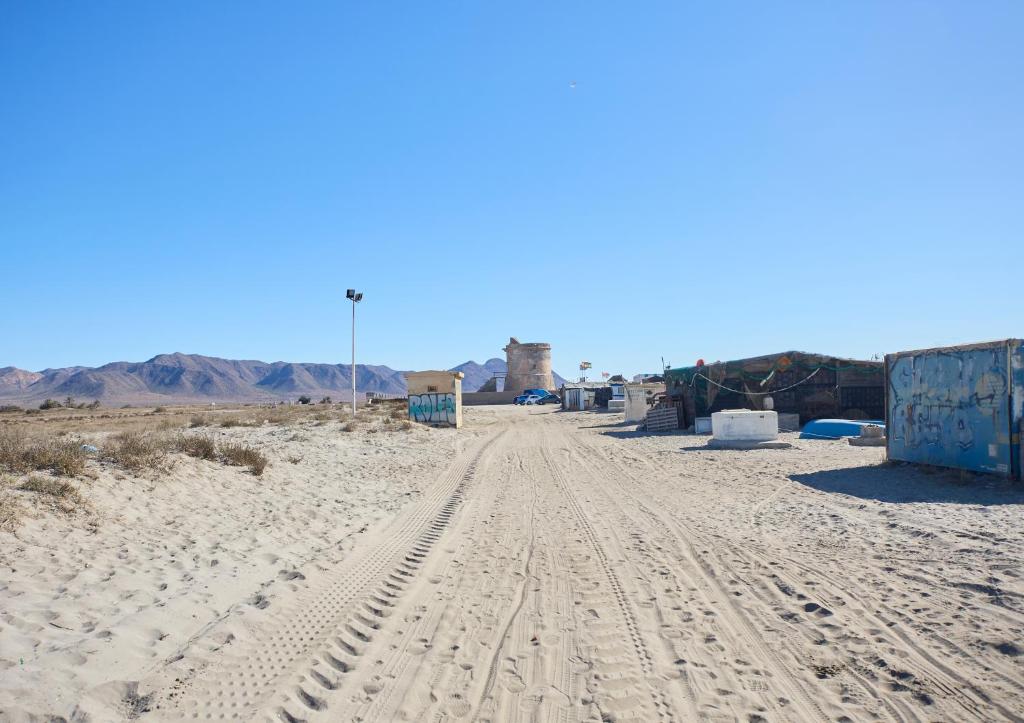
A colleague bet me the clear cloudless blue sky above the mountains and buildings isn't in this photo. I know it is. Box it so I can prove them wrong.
[0,0,1024,375]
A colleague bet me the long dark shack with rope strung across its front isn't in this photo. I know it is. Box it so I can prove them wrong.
[665,351,886,428]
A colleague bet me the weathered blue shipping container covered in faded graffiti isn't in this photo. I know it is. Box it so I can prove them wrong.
[886,339,1024,479]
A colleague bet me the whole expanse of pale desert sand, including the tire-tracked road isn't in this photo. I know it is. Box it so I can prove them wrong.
[0,407,1024,722]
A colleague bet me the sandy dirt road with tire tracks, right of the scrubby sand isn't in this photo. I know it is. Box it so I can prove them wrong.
[136,408,1024,721]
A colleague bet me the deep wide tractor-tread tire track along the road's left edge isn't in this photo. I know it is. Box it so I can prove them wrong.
[146,430,504,723]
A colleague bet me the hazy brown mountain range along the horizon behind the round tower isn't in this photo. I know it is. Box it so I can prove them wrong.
[0,353,561,405]
